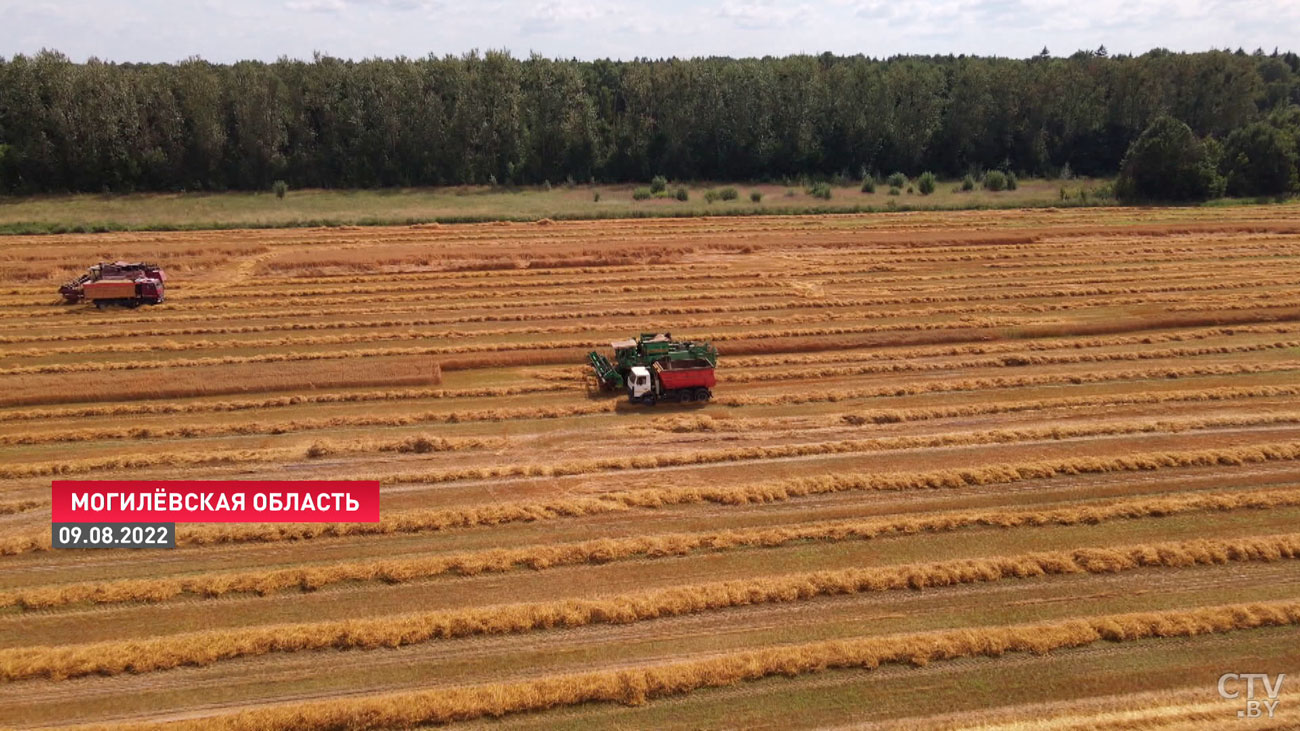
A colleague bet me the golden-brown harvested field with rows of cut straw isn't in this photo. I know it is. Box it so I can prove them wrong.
[0,204,1300,728]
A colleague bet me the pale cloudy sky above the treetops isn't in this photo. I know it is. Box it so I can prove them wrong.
[0,0,1300,62]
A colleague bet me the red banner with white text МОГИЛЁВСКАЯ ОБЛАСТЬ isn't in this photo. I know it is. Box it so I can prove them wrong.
[51,480,380,523]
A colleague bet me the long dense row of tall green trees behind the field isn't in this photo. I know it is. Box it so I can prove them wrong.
[0,48,1300,194]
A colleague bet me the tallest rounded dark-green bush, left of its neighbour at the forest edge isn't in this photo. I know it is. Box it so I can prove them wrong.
[1115,116,1223,200]
